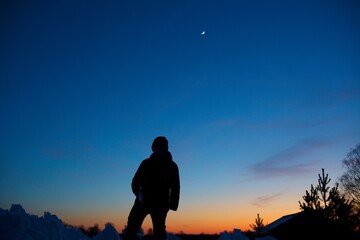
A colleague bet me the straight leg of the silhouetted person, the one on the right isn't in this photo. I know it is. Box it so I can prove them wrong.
[150,208,168,240]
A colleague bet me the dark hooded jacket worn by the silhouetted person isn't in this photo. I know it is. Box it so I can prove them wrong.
[131,152,180,211]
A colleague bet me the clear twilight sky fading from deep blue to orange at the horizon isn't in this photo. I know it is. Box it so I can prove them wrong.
[0,0,360,233]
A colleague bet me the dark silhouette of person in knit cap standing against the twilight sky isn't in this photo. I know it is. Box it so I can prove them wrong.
[125,136,180,240]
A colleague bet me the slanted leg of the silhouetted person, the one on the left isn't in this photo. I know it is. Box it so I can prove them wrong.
[125,200,149,240]
